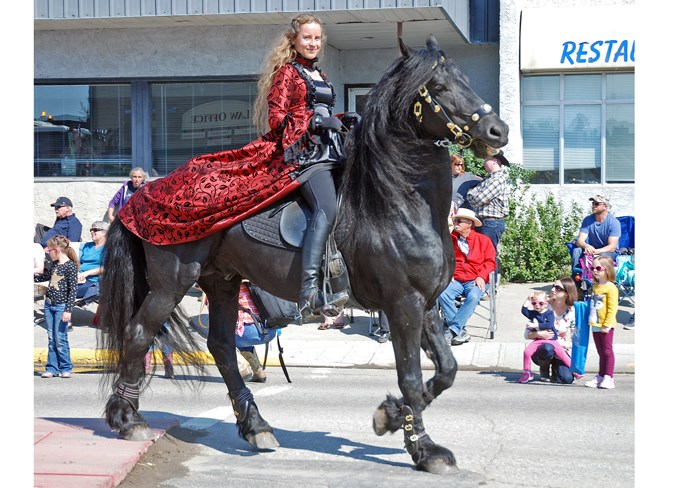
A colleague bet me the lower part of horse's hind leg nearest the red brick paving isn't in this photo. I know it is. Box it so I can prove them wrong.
[105,293,177,441]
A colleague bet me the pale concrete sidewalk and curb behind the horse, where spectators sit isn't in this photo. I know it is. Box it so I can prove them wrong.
[34,283,635,373]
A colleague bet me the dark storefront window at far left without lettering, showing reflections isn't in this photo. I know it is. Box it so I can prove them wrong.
[33,84,132,176]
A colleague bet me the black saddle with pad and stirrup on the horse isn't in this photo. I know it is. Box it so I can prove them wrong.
[240,195,352,308]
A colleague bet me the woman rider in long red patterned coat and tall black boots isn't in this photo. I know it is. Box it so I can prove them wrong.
[118,14,348,319]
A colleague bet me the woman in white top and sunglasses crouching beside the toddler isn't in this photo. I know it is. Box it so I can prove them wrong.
[524,277,578,384]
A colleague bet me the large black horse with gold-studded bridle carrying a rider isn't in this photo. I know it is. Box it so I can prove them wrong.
[100,36,508,473]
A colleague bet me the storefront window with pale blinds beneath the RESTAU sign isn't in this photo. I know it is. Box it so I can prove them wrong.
[522,73,635,184]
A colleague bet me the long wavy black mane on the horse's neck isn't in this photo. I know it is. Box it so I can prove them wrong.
[340,41,449,235]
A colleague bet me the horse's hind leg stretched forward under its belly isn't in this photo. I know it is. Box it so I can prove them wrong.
[199,273,280,449]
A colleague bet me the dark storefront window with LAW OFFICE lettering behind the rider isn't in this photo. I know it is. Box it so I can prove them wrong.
[151,81,258,175]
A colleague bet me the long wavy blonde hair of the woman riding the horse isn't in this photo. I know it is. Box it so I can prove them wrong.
[254,14,326,133]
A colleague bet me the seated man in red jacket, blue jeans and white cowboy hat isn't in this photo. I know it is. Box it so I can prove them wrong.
[439,208,496,346]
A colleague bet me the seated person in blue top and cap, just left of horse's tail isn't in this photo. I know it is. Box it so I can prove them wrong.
[75,220,109,306]
